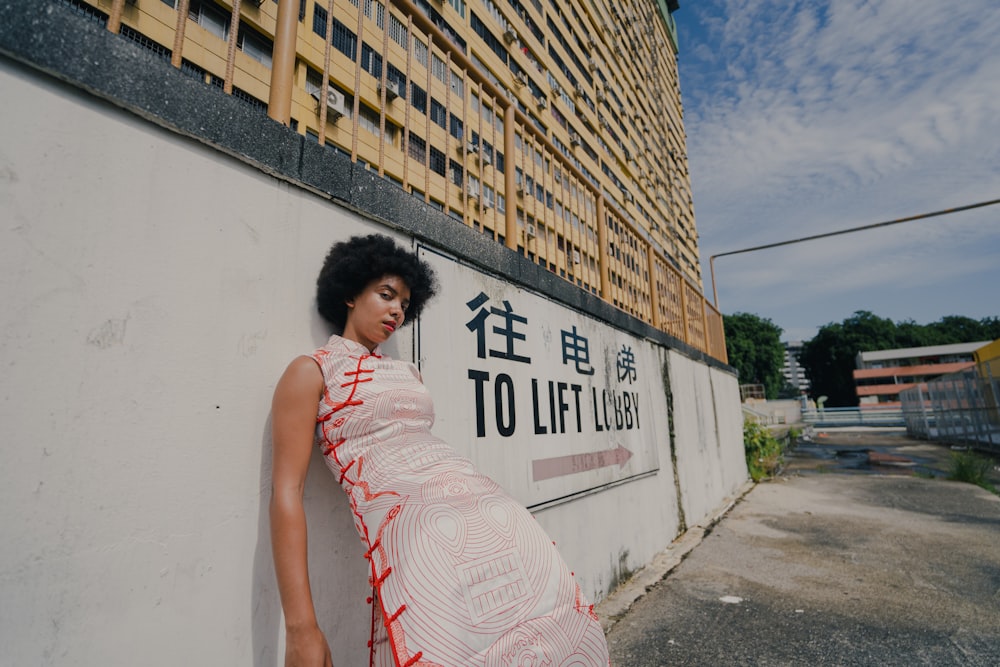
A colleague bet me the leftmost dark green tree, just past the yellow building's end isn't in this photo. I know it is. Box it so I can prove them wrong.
[722,313,785,398]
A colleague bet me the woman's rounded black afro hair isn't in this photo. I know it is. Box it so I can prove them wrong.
[316,234,437,330]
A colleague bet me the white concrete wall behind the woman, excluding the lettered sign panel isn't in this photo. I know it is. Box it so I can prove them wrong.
[0,59,746,667]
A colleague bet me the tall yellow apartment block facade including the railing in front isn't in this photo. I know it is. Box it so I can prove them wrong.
[58,0,725,361]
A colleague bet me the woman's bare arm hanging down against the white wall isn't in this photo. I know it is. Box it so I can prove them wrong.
[270,357,333,667]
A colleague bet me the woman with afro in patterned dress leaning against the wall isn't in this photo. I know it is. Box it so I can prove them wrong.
[271,235,608,667]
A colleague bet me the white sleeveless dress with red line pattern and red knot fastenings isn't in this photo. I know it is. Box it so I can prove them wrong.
[312,336,609,667]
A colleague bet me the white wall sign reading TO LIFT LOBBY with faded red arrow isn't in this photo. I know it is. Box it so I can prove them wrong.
[417,248,668,507]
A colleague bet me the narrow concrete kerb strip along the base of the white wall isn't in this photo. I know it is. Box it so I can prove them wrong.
[594,481,756,634]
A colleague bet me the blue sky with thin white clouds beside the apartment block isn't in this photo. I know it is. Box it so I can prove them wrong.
[674,0,1000,340]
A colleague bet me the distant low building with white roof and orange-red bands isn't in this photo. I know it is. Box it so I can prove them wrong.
[854,341,989,407]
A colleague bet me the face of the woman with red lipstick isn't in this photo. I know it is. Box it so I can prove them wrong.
[344,275,410,350]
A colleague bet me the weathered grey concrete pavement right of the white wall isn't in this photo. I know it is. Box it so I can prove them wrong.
[598,434,1000,667]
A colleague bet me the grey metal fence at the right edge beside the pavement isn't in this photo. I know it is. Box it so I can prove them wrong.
[899,357,1000,452]
